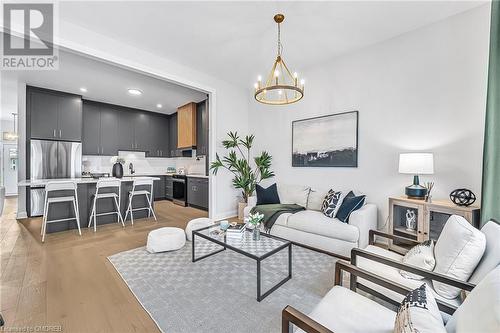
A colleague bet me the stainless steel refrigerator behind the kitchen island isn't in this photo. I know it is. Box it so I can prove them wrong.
[30,140,82,216]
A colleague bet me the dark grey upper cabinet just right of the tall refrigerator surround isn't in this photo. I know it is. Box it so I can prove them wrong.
[82,101,119,156]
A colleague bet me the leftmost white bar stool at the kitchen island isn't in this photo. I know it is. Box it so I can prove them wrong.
[40,180,82,243]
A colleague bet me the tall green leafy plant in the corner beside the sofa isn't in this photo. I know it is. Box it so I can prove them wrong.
[210,132,274,218]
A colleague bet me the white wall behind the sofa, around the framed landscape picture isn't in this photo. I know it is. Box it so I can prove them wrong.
[249,5,490,227]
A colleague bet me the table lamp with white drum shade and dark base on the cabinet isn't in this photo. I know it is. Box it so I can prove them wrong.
[399,153,434,199]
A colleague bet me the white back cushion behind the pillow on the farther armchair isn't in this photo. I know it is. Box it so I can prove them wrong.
[469,221,500,284]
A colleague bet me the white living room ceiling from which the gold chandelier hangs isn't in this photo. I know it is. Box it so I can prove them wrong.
[60,1,487,87]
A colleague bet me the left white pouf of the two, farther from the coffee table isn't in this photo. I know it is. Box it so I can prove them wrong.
[146,227,186,253]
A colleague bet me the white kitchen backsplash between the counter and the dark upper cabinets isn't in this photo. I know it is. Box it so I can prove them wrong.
[82,151,205,175]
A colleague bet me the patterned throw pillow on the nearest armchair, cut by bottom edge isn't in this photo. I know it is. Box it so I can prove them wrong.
[394,283,446,333]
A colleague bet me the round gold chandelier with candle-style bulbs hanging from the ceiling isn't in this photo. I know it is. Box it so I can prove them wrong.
[254,14,305,105]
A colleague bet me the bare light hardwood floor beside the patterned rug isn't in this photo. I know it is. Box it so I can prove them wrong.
[0,199,207,332]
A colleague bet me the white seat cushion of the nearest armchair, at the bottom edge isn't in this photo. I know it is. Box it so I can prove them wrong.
[297,286,396,333]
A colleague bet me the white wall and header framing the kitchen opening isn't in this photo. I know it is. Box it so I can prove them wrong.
[14,18,248,218]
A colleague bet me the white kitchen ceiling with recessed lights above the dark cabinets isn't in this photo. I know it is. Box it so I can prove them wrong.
[2,50,206,116]
